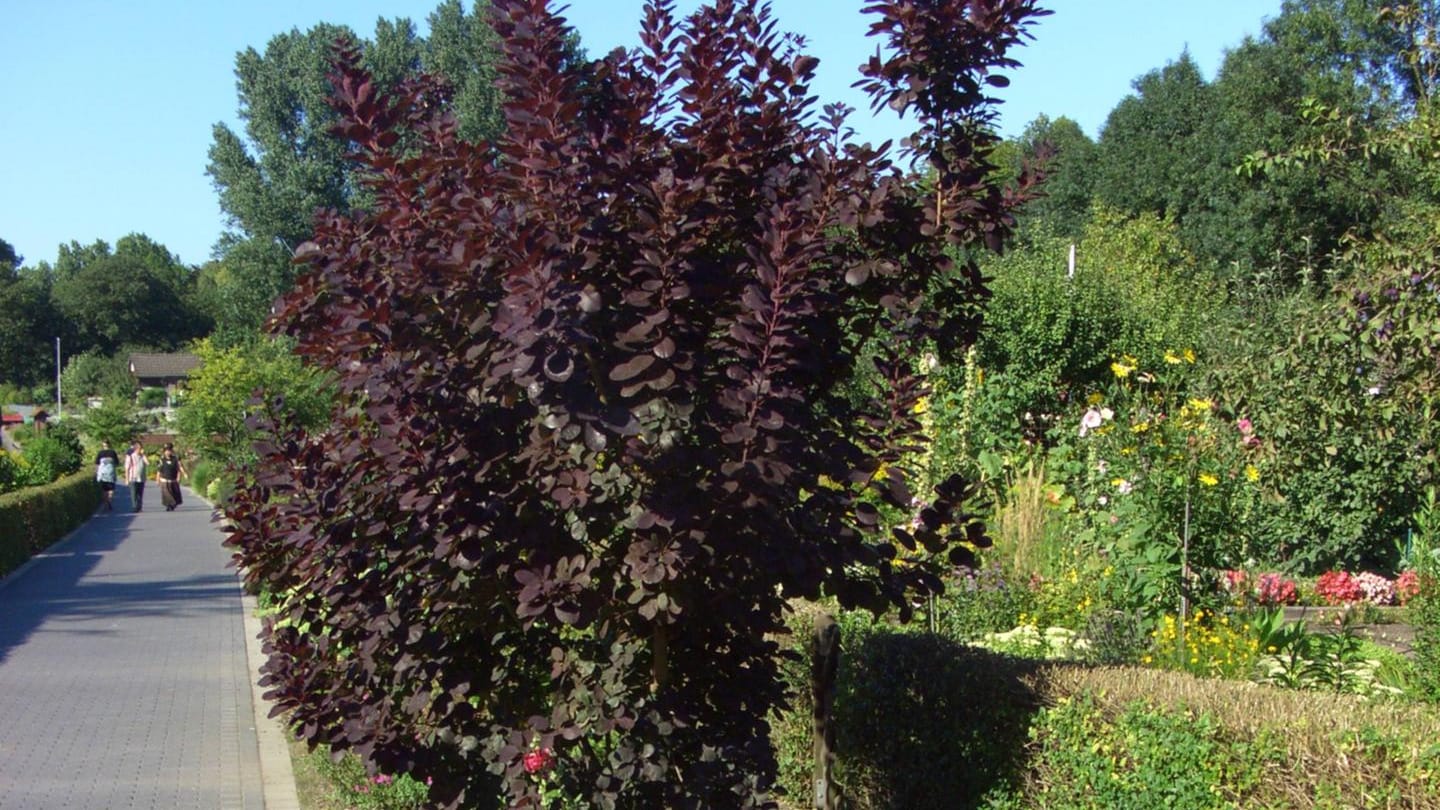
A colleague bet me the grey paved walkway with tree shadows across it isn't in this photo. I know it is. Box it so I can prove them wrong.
[0,486,294,810]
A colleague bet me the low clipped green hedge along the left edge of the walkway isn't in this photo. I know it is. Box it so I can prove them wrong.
[0,470,99,577]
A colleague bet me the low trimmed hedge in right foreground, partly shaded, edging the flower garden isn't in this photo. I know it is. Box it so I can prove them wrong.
[772,610,1440,810]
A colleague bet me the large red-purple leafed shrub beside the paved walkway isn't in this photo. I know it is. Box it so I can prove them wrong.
[229,0,1043,809]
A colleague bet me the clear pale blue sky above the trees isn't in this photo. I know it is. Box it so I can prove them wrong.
[0,0,1280,264]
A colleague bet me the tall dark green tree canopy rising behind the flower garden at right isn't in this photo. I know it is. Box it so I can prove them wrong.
[1094,0,1408,276]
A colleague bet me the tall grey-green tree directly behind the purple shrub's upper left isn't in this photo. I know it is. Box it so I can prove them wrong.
[207,0,518,343]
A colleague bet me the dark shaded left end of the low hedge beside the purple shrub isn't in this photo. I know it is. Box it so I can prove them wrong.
[772,613,1040,810]
